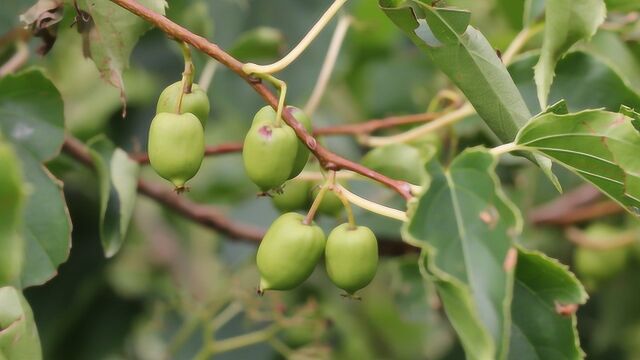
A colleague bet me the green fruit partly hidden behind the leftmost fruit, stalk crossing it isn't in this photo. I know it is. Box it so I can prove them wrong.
[156,81,211,128]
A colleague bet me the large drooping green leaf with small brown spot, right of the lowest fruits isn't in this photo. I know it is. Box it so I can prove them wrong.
[403,148,522,359]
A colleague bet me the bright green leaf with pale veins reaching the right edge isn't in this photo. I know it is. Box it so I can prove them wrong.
[516,110,640,214]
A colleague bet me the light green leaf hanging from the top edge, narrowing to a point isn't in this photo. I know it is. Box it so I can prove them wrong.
[535,0,607,109]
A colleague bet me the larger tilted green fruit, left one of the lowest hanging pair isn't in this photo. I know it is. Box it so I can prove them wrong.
[256,213,325,293]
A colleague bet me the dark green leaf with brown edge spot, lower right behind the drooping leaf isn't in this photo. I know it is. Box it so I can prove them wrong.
[509,249,587,360]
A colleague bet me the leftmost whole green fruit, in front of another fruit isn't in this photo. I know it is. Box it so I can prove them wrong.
[148,113,204,189]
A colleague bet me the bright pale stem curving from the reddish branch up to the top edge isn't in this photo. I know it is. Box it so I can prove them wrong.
[242,0,347,74]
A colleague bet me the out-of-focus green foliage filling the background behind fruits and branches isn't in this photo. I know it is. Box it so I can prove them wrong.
[0,0,640,359]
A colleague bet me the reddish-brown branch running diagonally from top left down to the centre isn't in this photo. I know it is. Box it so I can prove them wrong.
[111,0,411,200]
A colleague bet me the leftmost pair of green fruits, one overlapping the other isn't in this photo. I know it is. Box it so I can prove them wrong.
[148,81,210,192]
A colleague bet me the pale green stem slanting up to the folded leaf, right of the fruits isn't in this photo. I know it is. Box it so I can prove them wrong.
[361,103,475,147]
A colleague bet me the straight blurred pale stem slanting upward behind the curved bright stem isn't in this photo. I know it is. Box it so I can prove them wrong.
[304,16,351,116]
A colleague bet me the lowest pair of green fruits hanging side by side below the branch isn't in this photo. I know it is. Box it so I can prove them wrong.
[256,212,378,295]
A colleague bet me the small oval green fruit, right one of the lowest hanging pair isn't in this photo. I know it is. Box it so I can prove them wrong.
[325,224,378,295]
